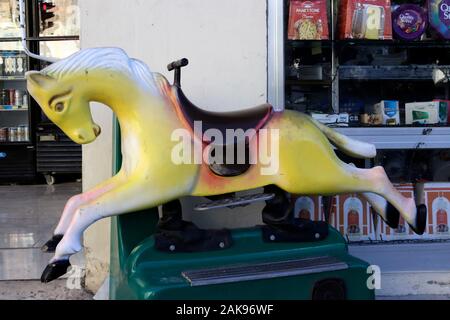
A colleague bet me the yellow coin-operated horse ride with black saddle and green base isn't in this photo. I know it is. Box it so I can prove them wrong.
[26,48,426,299]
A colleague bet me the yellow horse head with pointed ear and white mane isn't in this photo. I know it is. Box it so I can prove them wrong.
[26,48,151,144]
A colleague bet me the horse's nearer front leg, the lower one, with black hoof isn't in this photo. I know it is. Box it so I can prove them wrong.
[41,177,179,282]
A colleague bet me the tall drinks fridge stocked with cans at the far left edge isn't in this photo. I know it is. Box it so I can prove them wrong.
[0,0,35,182]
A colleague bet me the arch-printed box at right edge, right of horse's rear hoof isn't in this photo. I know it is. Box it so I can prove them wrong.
[424,183,450,239]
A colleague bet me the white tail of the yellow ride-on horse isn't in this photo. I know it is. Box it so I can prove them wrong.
[309,117,377,159]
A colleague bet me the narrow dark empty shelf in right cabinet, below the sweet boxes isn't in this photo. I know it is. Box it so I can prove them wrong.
[339,65,450,81]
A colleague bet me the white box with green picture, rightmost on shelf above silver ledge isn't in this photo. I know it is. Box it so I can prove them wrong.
[405,101,448,124]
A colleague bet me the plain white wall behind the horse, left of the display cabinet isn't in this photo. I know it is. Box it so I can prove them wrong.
[80,0,267,290]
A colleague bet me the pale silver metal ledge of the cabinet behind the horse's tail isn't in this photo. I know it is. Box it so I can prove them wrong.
[334,126,450,149]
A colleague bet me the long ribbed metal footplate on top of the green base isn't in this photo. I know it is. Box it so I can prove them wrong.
[181,256,348,287]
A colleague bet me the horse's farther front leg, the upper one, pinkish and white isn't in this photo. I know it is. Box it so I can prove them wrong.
[41,171,124,252]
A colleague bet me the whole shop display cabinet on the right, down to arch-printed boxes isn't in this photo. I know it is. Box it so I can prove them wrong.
[268,0,450,241]
